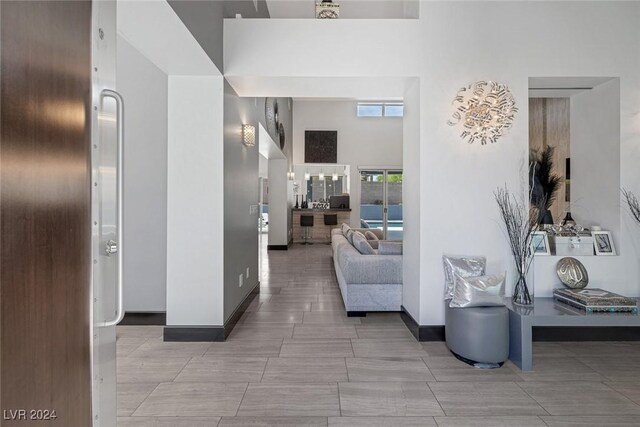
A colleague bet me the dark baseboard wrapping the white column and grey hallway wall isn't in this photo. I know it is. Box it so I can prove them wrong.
[163,282,260,342]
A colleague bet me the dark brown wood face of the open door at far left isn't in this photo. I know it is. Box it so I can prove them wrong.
[0,1,91,427]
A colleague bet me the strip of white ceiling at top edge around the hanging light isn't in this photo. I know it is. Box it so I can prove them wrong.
[267,0,419,19]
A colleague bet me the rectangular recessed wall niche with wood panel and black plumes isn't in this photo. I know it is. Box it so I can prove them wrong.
[529,77,620,249]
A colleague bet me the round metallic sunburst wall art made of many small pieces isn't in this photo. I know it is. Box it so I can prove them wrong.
[447,81,518,145]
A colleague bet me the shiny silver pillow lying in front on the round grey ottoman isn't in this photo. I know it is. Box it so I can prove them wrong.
[449,272,507,308]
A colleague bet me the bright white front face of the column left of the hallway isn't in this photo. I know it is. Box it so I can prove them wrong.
[167,76,225,326]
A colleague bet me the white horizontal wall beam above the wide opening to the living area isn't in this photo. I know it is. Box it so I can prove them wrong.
[224,19,420,77]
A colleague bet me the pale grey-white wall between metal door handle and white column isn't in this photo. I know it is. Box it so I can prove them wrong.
[116,37,167,312]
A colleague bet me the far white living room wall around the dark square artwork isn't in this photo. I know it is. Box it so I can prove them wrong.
[293,101,403,227]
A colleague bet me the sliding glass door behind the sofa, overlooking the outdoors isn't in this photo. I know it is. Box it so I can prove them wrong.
[360,169,403,240]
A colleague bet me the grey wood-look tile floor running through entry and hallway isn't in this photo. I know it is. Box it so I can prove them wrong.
[117,245,640,427]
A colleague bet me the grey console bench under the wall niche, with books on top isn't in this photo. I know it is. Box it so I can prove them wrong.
[505,298,640,371]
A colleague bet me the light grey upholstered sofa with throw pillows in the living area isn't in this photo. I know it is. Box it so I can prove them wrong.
[331,228,402,316]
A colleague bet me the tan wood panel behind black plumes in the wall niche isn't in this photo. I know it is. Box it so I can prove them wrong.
[529,98,571,223]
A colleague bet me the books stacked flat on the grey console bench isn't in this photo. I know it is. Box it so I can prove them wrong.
[553,288,638,314]
